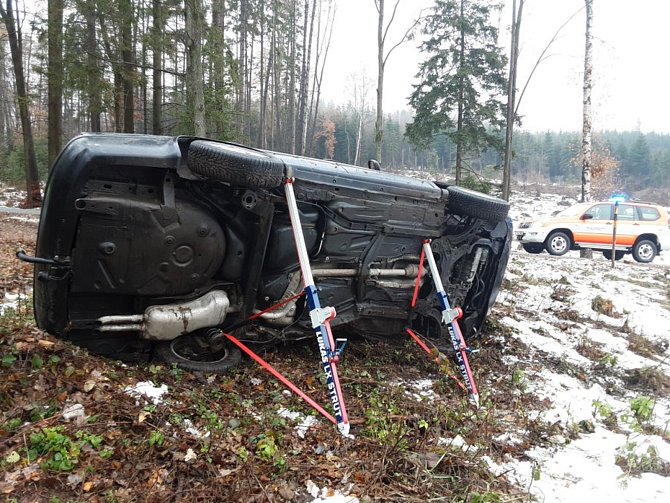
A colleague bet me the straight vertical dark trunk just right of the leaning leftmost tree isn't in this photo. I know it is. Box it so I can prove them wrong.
[47,0,63,166]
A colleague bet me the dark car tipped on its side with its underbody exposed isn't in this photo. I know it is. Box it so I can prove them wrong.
[22,134,512,372]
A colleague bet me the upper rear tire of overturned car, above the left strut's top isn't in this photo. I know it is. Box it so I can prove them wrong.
[188,140,284,189]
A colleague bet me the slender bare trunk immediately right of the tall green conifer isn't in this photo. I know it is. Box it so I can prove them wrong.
[502,0,525,201]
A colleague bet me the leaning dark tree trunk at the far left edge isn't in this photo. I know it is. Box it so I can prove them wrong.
[0,0,42,208]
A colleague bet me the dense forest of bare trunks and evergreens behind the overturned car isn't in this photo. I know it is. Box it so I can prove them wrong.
[0,0,670,204]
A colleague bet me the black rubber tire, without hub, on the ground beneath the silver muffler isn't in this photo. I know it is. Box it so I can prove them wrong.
[154,333,242,374]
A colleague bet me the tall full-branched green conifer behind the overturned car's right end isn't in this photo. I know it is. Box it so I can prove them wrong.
[407,0,507,184]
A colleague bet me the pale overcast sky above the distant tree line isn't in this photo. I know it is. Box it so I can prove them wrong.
[324,0,670,133]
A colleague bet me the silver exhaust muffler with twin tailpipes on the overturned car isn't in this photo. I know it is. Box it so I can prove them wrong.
[98,290,230,341]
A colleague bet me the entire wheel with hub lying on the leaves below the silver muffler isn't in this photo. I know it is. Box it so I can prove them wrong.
[154,330,242,374]
